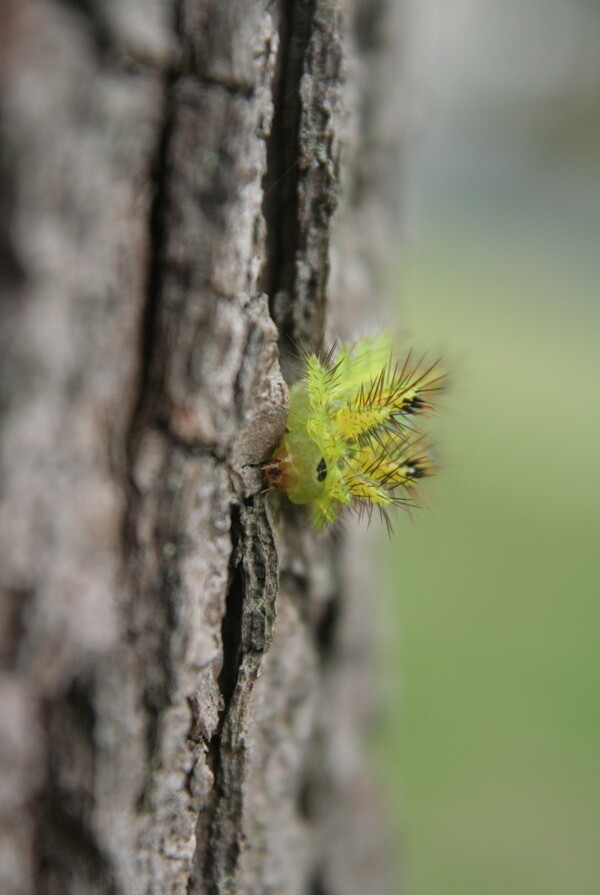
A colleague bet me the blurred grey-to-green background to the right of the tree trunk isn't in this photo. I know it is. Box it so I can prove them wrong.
[375,0,600,895]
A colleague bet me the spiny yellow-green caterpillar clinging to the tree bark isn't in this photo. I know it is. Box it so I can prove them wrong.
[264,336,443,531]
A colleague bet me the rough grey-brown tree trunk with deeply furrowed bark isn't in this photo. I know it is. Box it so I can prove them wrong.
[0,0,408,895]
